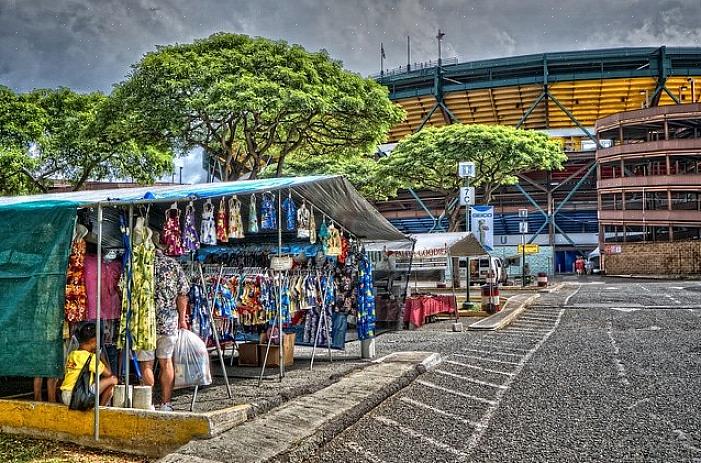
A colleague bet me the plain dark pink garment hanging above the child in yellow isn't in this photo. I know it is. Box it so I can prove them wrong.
[85,255,122,320]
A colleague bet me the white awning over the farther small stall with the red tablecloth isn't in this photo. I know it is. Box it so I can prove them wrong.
[365,232,489,257]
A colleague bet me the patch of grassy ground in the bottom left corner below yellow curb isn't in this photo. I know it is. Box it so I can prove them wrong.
[0,433,148,463]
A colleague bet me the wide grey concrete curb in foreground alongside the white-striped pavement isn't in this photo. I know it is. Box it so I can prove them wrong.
[160,352,441,463]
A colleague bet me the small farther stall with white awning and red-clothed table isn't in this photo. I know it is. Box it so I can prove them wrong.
[367,233,487,327]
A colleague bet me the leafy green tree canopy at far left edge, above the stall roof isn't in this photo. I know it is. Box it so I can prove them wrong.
[0,88,173,194]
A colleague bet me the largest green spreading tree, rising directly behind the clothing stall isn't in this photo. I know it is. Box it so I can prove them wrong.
[113,33,403,180]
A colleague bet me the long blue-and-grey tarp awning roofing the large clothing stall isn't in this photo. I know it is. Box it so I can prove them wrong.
[0,176,407,242]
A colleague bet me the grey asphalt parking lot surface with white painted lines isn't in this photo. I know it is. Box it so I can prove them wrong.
[300,278,701,463]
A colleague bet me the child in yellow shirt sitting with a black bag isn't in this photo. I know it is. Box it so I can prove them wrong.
[61,322,118,406]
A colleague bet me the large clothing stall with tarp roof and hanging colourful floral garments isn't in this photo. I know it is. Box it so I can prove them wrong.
[0,176,406,438]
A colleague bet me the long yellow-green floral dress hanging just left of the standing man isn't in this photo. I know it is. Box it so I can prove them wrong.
[117,224,156,351]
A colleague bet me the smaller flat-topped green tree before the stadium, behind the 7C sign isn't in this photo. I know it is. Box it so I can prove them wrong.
[379,124,567,231]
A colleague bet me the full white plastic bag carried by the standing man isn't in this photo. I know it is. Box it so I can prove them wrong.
[173,330,212,389]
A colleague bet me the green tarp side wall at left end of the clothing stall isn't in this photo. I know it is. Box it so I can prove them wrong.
[0,201,76,377]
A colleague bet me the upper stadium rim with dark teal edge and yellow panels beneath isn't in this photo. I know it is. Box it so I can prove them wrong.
[378,47,701,141]
